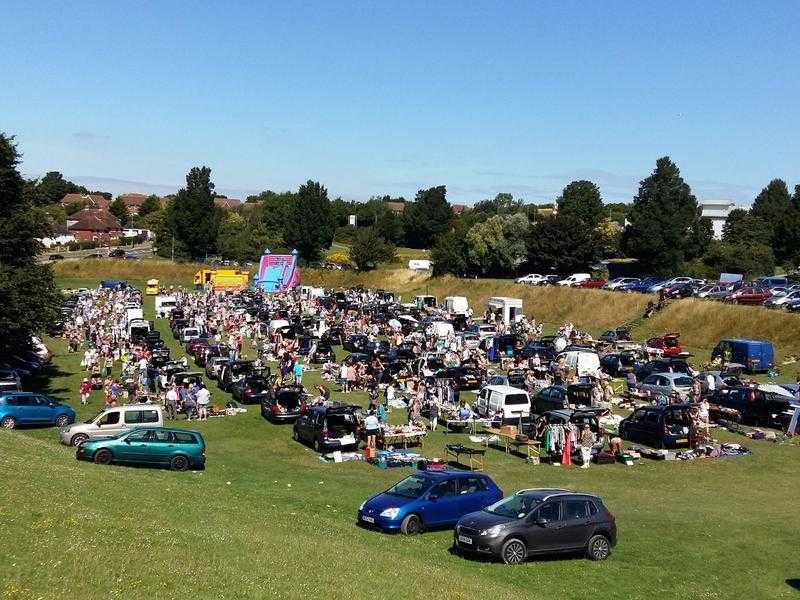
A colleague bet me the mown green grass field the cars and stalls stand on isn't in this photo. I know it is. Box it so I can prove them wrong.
[0,274,800,600]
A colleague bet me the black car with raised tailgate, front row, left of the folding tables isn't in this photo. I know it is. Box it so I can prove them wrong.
[292,403,361,452]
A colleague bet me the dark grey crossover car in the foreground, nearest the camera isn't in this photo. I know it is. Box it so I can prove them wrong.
[453,489,617,564]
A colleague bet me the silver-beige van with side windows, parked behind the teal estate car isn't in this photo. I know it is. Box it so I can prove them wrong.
[59,404,164,446]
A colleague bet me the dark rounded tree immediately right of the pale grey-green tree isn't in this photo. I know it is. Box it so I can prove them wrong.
[528,214,596,274]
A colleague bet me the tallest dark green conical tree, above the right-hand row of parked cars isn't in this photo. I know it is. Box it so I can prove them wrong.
[622,156,707,275]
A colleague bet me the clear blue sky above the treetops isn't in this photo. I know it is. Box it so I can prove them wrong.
[0,1,800,204]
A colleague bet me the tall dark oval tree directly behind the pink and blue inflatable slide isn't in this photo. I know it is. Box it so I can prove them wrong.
[283,179,335,262]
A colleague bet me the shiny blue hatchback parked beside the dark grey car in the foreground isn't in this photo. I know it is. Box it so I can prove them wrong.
[358,471,503,535]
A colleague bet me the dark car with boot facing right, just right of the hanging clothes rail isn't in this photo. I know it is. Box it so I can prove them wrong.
[619,404,693,448]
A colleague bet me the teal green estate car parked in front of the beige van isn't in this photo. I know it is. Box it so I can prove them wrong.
[75,427,206,471]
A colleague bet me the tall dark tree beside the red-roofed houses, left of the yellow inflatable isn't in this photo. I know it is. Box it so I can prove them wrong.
[165,167,220,258]
